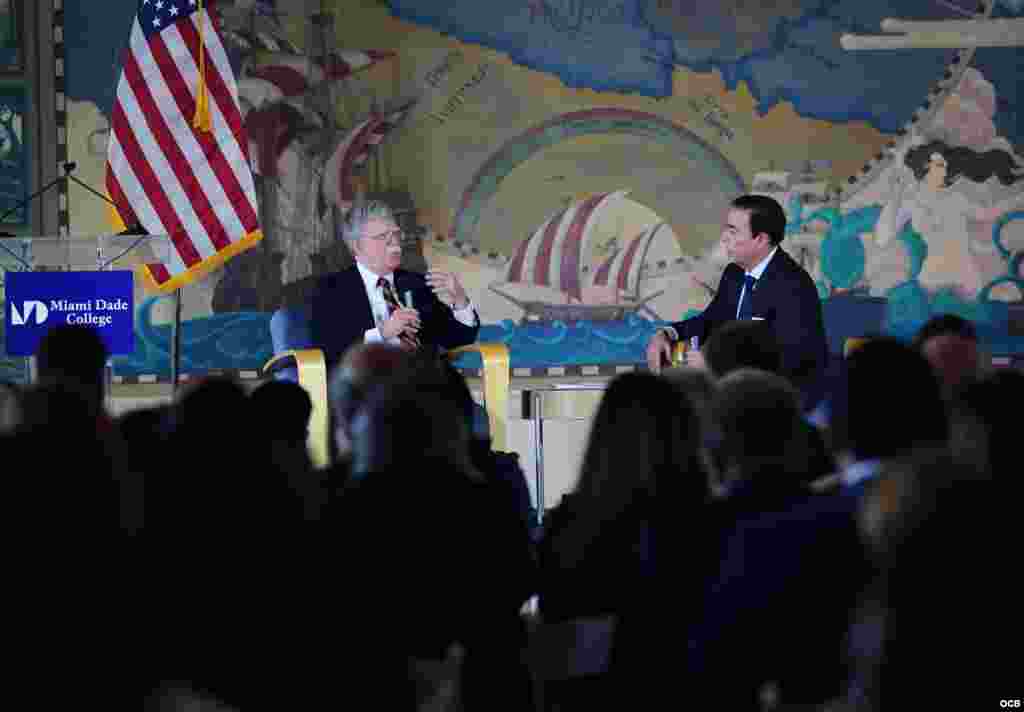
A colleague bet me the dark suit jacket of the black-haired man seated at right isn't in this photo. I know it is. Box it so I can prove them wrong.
[672,247,828,394]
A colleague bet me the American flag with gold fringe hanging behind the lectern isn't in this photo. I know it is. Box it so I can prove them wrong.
[106,0,262,292]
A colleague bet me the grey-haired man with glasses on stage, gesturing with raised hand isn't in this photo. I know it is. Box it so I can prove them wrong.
[310,201,479,369]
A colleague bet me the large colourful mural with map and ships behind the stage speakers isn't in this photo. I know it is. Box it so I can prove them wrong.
[39,0,1024,377]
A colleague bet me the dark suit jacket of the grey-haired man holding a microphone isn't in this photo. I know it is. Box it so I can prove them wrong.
[310,264,480,369]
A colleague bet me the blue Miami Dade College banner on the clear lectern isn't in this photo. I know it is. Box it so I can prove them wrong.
[4,270,135,355]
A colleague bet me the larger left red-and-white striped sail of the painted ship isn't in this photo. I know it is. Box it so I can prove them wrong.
[505,191,628,300]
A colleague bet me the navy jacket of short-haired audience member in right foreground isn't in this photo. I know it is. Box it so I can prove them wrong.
[687,494,870,710]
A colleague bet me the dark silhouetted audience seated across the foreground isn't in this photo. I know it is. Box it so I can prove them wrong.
[6,318,1024,712]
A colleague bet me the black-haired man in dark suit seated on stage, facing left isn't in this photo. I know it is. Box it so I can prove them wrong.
[647,196,828,406]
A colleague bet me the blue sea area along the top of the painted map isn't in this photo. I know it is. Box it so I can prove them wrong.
[390,0,1024,146]
